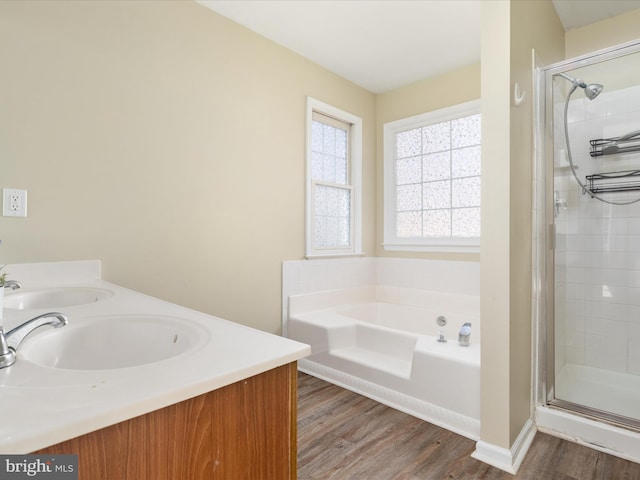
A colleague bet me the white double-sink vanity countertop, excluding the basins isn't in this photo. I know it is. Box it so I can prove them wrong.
[0,264,310,454]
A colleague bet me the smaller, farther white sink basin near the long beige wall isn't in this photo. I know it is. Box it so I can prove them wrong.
[4,287,113,310]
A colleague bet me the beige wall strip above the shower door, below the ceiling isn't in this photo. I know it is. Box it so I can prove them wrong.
[565,9,640,58]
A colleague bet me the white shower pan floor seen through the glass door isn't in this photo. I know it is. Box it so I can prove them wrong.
[548,364,640,431]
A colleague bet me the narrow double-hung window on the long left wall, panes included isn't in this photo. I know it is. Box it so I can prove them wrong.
[306,98,362,257]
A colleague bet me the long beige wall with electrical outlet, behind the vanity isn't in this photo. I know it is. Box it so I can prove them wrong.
[0,1,375,332]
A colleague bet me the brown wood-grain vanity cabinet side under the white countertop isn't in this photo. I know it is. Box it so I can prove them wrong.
[35,362,297,480]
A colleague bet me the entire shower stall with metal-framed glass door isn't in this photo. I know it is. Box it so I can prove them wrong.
[534,42,640,461]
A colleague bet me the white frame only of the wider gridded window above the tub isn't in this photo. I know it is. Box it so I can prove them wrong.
[382,99,482,253]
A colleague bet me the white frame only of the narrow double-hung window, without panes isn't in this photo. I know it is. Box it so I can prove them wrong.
[305,97,363,258]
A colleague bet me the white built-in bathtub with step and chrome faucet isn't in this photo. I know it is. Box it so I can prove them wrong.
[284,285,480,440]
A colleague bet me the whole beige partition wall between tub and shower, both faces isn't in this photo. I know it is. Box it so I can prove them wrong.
[481,0,564,449]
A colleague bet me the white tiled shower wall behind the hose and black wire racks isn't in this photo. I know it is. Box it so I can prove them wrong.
[554,86,640,375]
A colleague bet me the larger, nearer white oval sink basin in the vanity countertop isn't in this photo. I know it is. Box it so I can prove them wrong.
[18,315,209,370]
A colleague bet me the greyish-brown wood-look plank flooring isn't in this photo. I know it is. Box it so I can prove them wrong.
[298,372,640,480]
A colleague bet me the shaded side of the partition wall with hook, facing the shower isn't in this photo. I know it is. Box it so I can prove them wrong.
[509,0,564,442]
